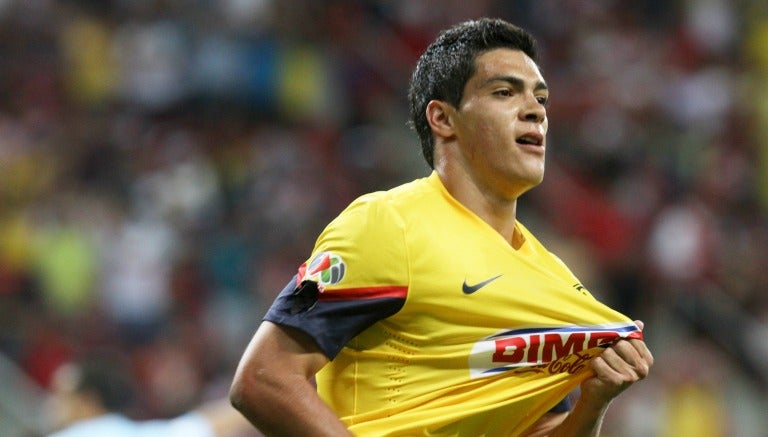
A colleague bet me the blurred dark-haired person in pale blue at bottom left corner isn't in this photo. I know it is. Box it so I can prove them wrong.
[50,358,258,437]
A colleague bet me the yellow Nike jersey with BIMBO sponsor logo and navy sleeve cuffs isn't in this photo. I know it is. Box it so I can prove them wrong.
[265,172,641,436]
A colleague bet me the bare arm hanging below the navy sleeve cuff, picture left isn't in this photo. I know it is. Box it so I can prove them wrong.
[230,321,352,436]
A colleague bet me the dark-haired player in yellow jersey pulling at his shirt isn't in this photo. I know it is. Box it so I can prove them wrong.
[230,19,653,436]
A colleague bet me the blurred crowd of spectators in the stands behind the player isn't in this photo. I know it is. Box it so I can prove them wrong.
[0,0,768,436]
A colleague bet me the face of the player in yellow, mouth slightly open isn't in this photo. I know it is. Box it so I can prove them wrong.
[453,49,549,200]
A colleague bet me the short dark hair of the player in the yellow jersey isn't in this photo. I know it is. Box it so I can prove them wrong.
[408,18,536,168]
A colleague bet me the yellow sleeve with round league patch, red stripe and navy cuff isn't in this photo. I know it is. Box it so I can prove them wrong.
[264,194,409,359]
